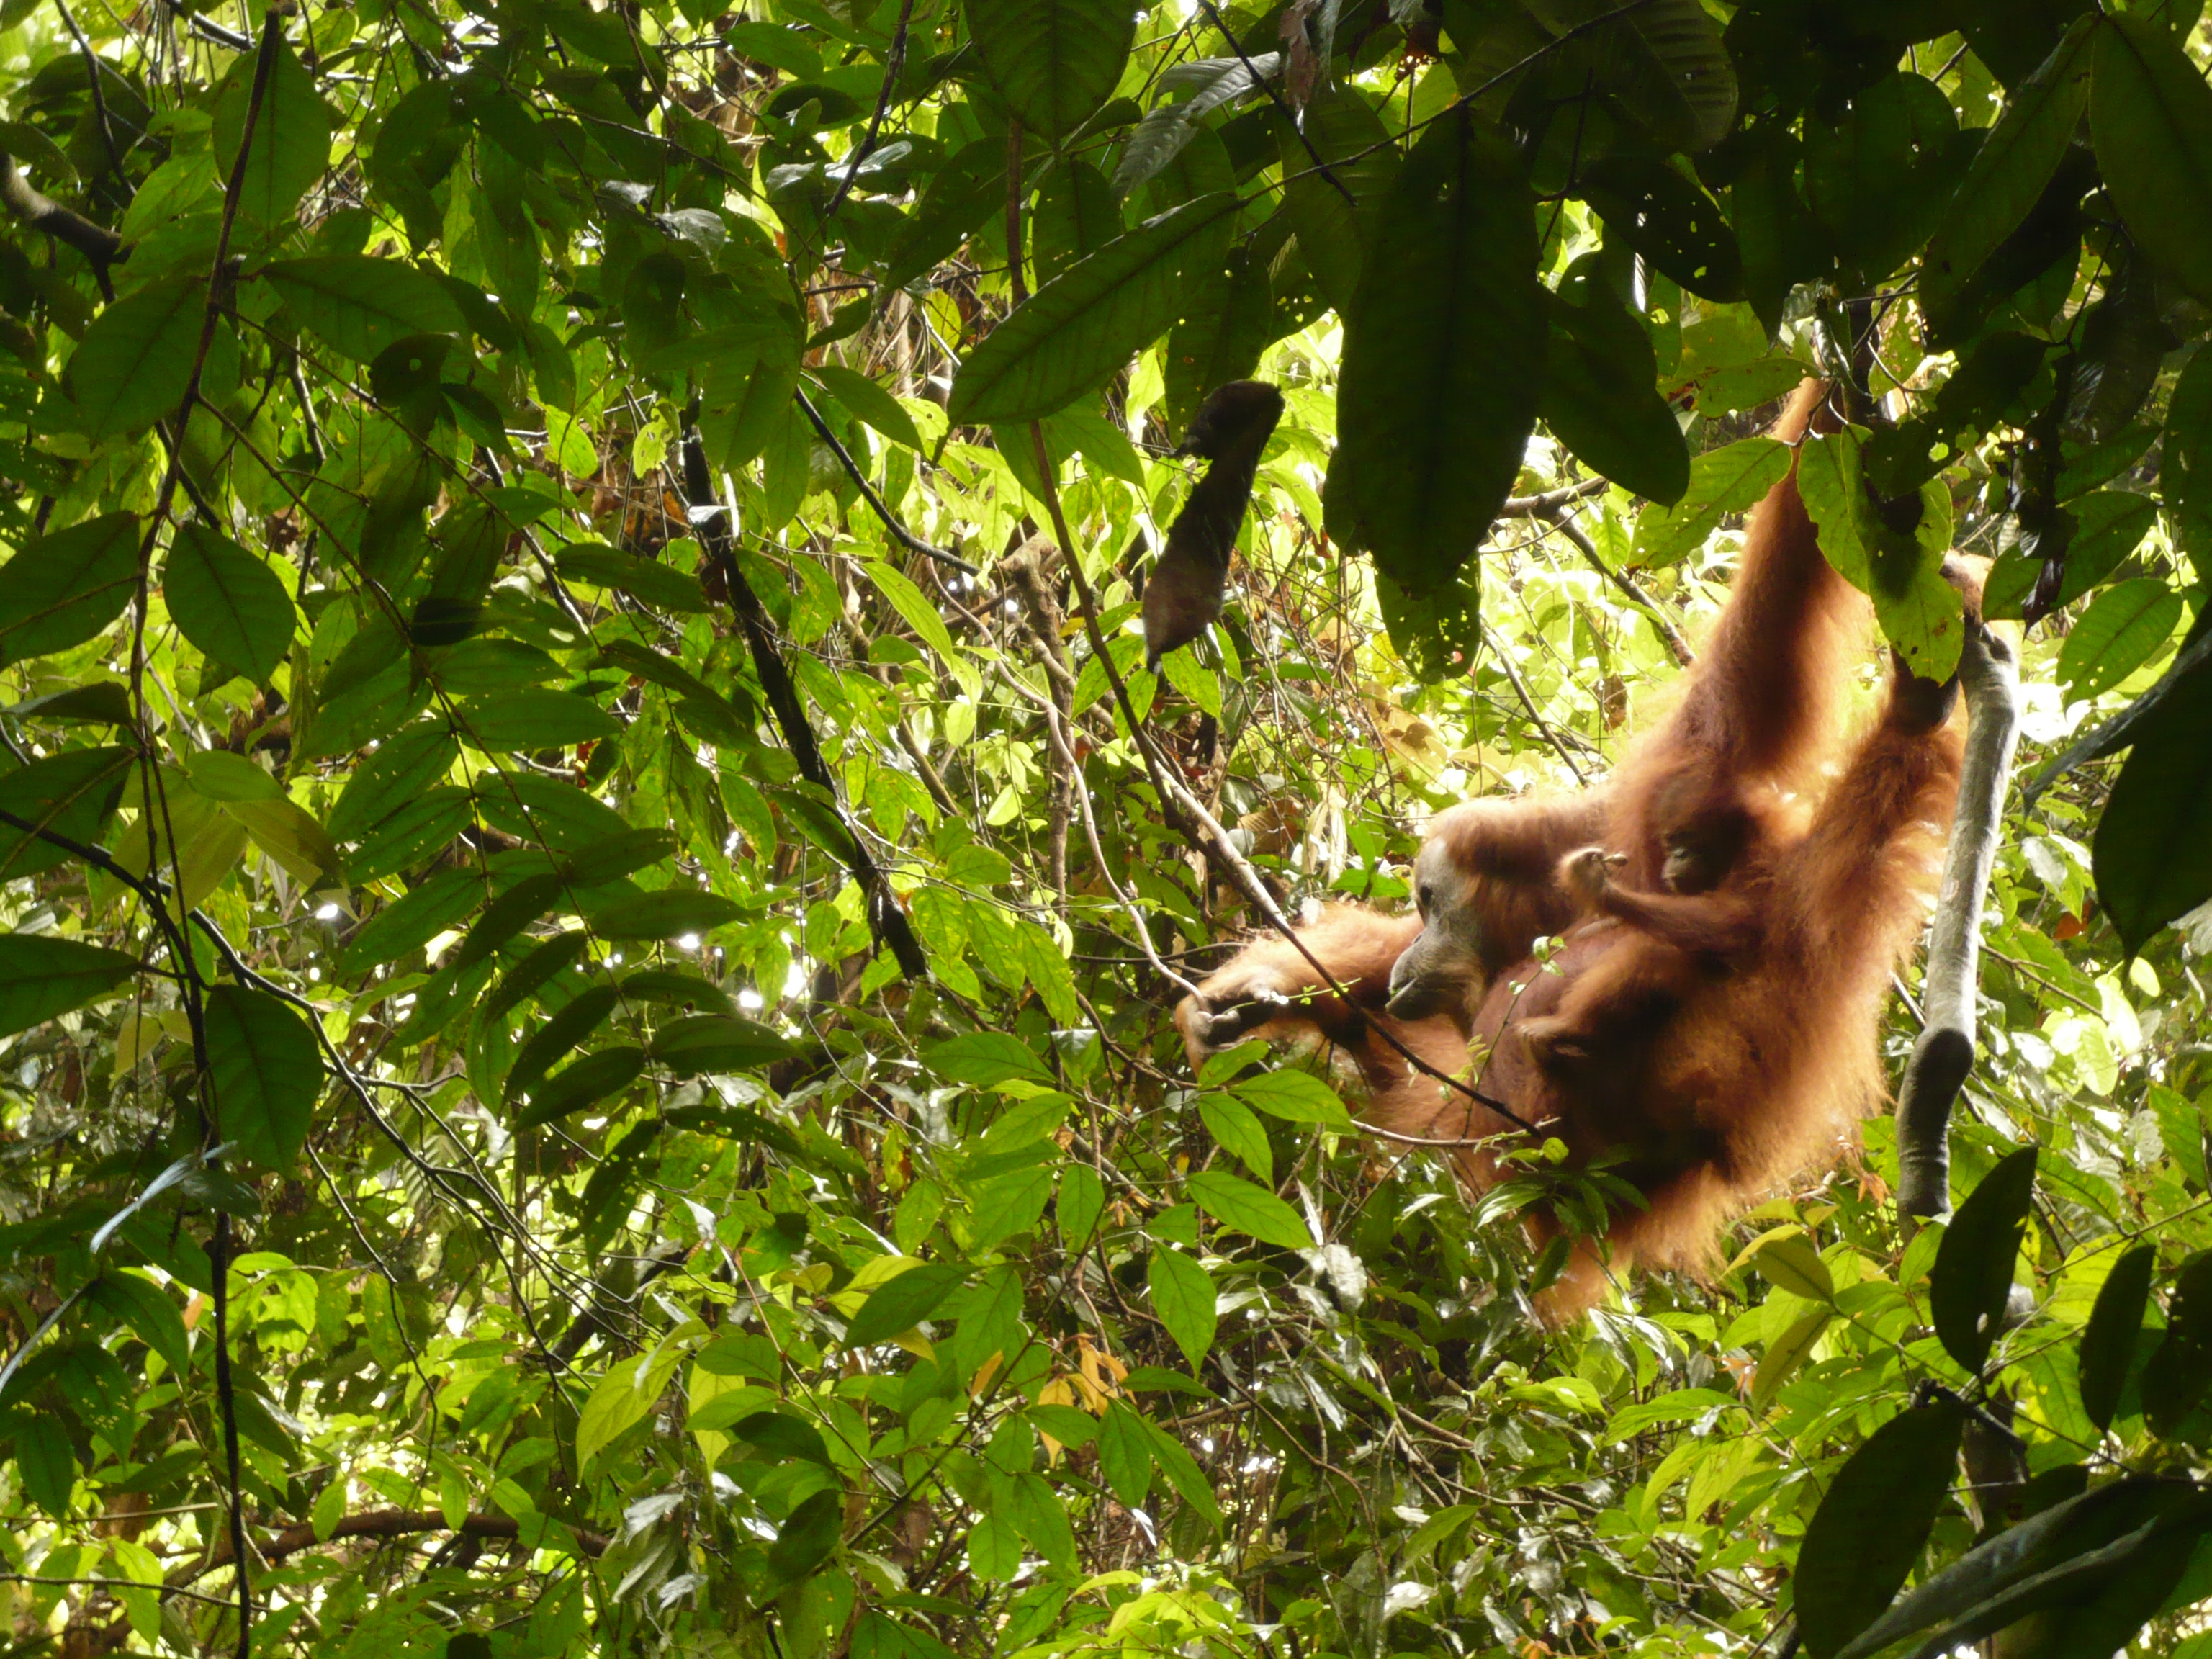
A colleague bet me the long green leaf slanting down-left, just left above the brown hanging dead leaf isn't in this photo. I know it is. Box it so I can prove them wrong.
[947,192,1238,425]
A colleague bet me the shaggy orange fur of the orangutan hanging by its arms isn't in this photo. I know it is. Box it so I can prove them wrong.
[1177,382,1962,1316]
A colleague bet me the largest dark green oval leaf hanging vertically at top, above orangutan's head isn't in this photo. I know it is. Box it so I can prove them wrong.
[1323,109,1546,595]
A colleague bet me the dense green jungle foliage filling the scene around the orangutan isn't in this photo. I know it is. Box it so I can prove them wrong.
[0,0,2212,1659]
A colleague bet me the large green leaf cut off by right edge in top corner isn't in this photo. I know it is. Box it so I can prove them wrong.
[2088,13,2212,303]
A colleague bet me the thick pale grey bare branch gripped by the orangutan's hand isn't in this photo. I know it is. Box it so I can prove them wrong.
[1898,626,2020,1236]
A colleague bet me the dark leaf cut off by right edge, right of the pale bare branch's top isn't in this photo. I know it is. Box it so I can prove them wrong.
[2090,666,2212,956]
